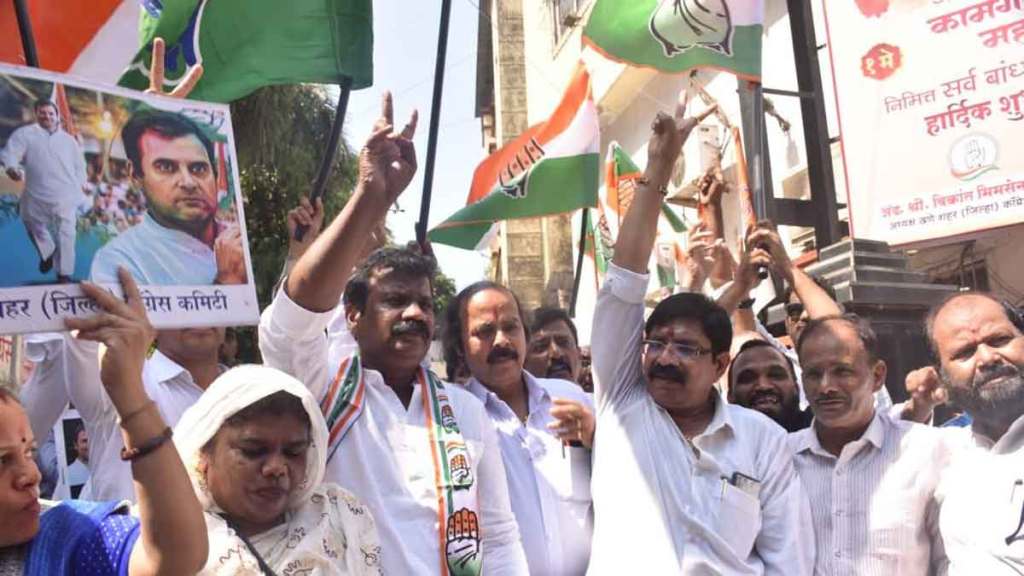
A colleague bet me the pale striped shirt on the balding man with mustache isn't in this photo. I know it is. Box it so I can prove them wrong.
[790,410,949,576]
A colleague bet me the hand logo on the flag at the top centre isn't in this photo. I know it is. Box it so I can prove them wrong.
[649,0,732,57]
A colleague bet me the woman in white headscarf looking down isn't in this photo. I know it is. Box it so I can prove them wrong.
[174,366,381,575]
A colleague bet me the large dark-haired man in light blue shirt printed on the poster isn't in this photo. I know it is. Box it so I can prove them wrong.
[90,110,247,285]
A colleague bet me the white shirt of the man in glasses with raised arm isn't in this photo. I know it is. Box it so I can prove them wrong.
[589,264,814,575]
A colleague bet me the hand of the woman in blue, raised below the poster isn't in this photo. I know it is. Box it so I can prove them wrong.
[65,268,157,405]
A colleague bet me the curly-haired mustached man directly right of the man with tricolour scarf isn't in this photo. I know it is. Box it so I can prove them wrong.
[444,281,594,576]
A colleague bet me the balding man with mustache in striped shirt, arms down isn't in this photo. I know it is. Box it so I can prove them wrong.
[790,315,948,576]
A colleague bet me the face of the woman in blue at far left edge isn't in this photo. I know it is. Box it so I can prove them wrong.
[0,399,42,548]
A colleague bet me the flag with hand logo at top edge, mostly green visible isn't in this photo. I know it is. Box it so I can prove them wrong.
[583,0,764,80]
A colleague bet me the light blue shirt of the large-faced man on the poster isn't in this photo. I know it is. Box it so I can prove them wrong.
[89,213,217,286]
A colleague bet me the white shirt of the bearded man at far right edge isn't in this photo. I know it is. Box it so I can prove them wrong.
[937,416,1024,576]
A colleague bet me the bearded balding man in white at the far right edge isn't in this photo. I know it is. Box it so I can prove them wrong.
[909,292,1024,576]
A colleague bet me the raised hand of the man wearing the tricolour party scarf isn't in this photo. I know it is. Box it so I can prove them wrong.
[359,92,419,204]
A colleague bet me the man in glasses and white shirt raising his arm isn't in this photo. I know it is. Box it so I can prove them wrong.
[589,97,814,575]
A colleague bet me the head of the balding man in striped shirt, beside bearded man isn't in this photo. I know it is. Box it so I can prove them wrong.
[798,320,886,428]
